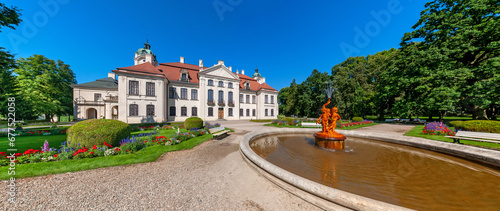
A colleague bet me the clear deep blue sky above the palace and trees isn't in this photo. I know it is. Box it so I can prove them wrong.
[0,0,425,90]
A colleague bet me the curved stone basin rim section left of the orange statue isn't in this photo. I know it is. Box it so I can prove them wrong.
[240,129,410,211]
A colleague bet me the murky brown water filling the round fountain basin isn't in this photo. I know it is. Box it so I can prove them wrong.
[250,135,500,210]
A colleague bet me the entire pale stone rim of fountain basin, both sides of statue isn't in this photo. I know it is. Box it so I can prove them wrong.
[240,128,500,210]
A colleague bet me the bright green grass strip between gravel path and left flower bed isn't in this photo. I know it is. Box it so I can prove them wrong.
[0,134,212,180]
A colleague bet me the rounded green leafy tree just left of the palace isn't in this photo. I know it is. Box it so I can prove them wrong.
[14,55,76,119]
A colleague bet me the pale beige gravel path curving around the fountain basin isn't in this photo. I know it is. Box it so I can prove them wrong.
[0,121,411,210]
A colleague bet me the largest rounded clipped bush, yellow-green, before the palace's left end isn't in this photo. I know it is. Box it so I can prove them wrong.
[66,119,130,147]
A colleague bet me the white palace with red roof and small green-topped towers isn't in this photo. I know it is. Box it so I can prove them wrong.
[72,43,278,123]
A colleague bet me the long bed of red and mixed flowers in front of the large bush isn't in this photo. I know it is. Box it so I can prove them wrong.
[0,129,207,166]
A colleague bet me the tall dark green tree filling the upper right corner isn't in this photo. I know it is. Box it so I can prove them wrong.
[401,0,500,119]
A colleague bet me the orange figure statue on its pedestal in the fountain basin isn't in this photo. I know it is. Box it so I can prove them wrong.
[314,82,346,150]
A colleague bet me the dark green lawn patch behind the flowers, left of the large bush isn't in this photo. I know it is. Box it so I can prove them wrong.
[0,135,66,153]
